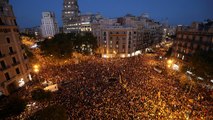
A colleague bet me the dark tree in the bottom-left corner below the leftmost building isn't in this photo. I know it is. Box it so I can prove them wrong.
[0,96,27,119]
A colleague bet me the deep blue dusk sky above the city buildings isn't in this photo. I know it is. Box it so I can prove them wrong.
[10,0,213,28]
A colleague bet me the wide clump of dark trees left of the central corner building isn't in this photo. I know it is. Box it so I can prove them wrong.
[40,33,97,58]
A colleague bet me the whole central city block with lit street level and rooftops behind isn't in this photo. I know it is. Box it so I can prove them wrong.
[92,14,163,57]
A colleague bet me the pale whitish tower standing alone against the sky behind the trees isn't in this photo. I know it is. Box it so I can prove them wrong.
[41,12,59,38]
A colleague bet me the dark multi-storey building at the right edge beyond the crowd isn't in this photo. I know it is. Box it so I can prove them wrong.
[172,20,213,61]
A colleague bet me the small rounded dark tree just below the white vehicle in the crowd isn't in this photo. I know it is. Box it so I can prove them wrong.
[31,88,51,101]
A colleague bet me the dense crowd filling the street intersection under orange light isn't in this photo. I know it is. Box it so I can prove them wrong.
[27,56,213,119]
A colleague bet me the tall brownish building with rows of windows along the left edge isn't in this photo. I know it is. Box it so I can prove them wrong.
[0,0,31,96]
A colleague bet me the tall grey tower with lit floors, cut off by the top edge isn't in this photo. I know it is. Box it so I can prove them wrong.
[62,0,80,33]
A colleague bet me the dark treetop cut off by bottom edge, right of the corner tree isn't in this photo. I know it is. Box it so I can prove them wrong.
[29,105,68,120]
